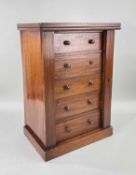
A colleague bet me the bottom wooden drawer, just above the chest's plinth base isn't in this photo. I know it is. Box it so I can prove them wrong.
[56,112,100,141]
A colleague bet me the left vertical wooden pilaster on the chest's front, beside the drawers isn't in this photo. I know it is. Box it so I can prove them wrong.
[42,32,56,147]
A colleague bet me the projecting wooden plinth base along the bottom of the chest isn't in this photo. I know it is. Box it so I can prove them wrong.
[24,126,113,161]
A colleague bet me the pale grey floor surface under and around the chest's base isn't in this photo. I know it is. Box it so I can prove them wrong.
[0,112,136,175]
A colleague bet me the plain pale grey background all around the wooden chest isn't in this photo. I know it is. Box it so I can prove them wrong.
[0,0,136,175]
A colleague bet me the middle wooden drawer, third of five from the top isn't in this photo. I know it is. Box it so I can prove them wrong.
[55,74,101,99]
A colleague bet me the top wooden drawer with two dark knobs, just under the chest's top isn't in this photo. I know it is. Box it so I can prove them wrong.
[54,33,102,53]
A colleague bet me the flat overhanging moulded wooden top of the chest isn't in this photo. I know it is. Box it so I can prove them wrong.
[17,23,121,31]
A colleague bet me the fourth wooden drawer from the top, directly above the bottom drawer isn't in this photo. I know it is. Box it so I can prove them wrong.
[56,93,100,119]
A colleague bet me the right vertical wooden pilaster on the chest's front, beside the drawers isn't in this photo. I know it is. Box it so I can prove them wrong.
[101,30,114,128]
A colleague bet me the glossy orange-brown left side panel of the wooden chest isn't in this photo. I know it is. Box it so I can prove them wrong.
[21,31,46,145]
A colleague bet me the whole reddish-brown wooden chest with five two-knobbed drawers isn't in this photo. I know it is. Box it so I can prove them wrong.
[18,23,120,160]
